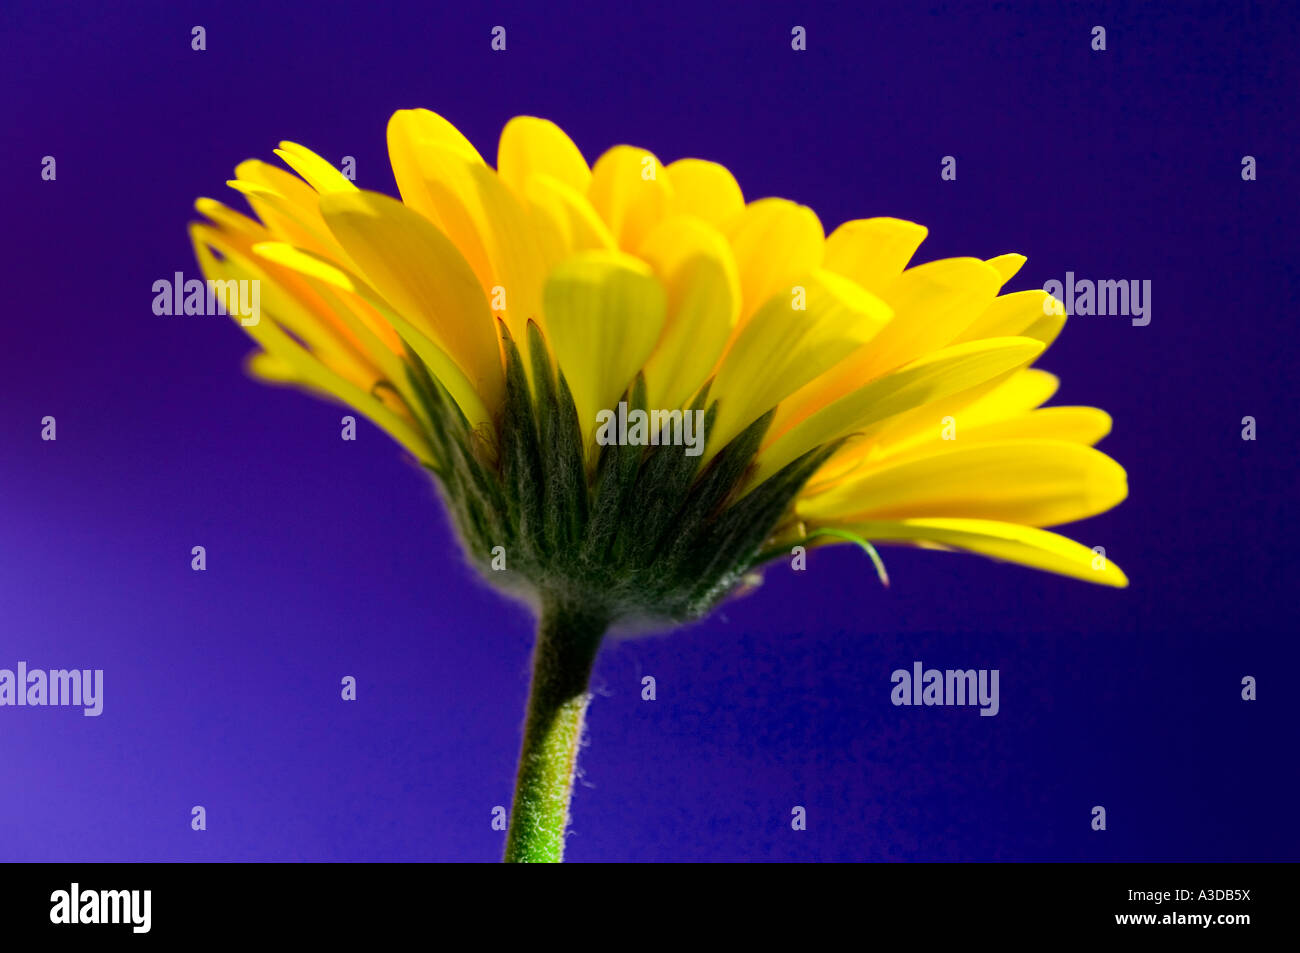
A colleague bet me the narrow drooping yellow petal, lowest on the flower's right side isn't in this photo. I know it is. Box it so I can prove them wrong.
[821,519,1128,589]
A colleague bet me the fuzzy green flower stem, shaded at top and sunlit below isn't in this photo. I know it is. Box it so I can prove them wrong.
[506,599,608,863]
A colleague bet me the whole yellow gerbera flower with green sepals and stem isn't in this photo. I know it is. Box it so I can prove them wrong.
[191,109,1127,859]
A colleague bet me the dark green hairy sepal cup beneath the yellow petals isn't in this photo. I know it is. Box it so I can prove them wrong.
[408,330,837,621]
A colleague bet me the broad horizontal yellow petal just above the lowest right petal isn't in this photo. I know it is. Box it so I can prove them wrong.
[797,438,1128,527]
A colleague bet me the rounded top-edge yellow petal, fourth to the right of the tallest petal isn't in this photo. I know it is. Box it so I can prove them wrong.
[728,199,823,328]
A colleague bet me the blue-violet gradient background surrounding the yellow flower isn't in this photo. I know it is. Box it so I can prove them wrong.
[0,3,1300,861]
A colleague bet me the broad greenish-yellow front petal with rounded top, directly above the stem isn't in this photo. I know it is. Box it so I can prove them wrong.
[543,251,666,450]
